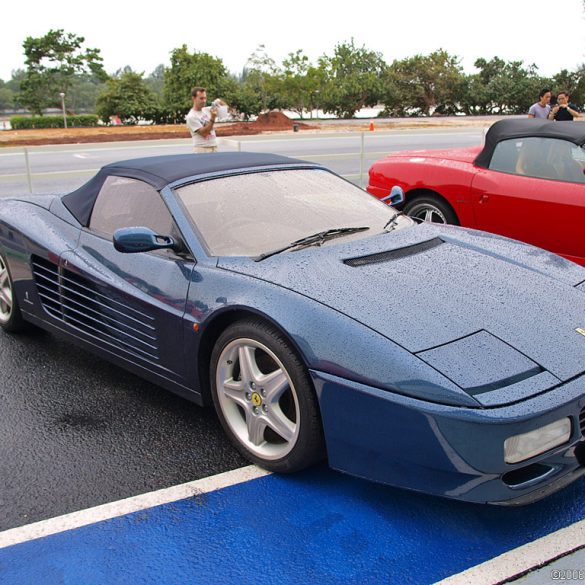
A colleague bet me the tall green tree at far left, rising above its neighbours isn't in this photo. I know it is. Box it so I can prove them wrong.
[19,29,107,115]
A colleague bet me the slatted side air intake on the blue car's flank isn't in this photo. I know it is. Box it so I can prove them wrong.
[32,257,159,363]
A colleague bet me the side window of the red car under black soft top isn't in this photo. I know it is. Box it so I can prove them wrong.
[490,137,585,183]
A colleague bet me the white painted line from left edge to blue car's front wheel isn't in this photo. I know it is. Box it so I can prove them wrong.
[0,465,270,549]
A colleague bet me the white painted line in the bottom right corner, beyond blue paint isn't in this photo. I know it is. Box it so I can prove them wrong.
[439,520,585,585]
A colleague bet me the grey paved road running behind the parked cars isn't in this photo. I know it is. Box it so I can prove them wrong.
[0,128,483,197]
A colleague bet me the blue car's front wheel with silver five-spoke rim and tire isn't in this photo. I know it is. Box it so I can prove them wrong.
[210,319,325,473]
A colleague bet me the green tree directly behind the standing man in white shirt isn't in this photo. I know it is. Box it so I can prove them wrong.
[163,45,236,119]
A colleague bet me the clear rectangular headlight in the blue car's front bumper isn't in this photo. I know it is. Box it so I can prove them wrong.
[504,417,571,463]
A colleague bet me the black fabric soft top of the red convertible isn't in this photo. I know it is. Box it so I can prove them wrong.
[475,118,585,169]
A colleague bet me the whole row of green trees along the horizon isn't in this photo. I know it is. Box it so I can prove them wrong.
[0,29,585,124]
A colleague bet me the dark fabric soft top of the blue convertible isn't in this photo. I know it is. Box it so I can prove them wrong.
[61,152,318,225]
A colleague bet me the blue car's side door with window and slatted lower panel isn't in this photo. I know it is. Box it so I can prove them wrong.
[61,177,194,385]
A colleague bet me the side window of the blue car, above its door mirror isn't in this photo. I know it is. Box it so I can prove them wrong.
[89,177,174,236]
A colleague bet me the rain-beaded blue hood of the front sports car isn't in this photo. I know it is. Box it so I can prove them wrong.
[218,224,585,386]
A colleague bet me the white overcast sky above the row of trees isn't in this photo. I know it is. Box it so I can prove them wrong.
[0,0,585,80]
